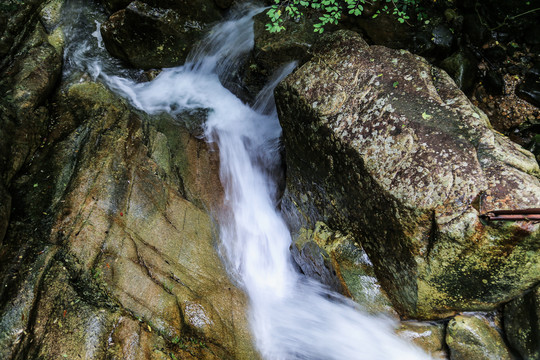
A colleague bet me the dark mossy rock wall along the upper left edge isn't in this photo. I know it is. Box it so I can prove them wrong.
[0,1,62,245]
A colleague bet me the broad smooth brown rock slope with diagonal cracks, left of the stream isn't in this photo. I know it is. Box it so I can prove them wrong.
[0,80,258,359]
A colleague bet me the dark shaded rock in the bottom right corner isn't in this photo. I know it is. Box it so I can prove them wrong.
[504,287,540,360]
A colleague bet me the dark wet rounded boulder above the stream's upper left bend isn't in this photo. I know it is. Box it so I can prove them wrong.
[101,1,214,69]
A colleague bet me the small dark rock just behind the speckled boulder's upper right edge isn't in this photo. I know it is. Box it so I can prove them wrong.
[440,50,478,91]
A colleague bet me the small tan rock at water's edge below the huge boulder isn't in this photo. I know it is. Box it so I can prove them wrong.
[396,321,448,359]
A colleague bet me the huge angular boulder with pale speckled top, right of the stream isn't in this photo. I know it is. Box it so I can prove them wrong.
[276,31,540,318]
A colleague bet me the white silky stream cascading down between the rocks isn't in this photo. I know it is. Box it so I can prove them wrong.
[66,2,429,360]
